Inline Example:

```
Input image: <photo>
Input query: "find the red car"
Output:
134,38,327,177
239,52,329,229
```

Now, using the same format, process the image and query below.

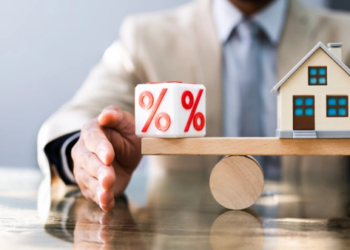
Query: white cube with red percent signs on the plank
135,82,206,138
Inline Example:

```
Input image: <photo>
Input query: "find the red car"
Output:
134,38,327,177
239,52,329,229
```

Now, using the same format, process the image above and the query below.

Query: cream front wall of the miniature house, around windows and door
278,48,350,130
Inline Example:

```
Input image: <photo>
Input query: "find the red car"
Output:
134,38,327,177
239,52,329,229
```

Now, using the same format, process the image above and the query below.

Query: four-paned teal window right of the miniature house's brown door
327,96,349,117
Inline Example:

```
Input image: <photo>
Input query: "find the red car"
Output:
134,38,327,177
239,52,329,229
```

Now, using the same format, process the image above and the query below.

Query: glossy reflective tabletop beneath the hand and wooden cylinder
0,159,350,249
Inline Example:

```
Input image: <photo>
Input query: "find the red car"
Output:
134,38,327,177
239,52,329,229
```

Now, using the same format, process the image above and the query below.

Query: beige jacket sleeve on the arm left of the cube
37,17,146,182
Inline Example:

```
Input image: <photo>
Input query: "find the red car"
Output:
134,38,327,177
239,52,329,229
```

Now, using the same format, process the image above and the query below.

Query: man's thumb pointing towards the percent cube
98,106,135,135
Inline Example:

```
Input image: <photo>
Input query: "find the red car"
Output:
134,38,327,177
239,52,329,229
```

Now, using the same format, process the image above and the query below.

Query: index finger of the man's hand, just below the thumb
81,120,114,165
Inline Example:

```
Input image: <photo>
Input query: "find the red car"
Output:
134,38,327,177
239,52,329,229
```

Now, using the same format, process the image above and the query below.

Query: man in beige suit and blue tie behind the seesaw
38,0,350,211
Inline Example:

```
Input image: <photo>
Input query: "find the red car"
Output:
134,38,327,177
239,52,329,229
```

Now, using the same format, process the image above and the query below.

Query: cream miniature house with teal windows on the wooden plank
273,42,350,138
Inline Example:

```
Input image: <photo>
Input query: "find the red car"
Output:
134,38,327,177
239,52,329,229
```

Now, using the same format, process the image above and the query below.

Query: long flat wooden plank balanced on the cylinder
142,137,350,155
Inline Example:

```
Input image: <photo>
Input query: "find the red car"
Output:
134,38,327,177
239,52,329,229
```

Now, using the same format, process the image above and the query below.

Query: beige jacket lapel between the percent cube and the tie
193,0,222,136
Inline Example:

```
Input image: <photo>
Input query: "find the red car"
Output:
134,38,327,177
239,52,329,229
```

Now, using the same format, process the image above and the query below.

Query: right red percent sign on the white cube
181,89,205,132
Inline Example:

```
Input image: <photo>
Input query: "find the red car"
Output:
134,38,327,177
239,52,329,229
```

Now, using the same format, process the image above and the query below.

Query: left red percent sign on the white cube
139,89,171,133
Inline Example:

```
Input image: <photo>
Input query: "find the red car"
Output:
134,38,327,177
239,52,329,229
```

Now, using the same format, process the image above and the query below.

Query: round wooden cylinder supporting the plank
209,156,264,210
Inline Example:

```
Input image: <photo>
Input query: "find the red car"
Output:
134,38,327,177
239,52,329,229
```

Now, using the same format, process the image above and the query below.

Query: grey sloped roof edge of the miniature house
271,42,350,91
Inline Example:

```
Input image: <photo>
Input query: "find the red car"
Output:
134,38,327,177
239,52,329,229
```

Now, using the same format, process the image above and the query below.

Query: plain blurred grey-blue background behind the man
0,0,350,168
